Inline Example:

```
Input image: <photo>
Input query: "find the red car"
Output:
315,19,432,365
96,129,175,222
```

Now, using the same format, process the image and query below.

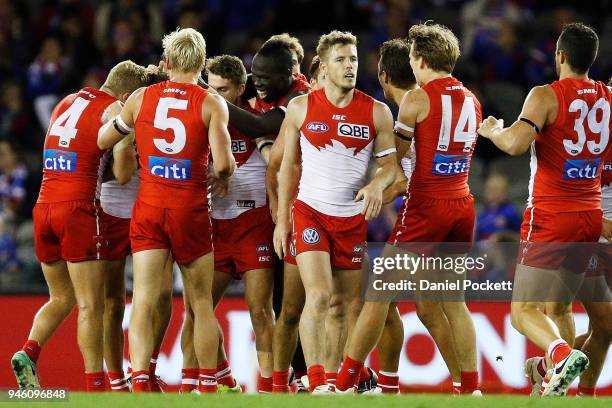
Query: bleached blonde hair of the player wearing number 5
162,28,206,73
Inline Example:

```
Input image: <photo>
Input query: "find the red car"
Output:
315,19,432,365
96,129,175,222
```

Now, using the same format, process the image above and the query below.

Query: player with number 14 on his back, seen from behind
337,24,481,394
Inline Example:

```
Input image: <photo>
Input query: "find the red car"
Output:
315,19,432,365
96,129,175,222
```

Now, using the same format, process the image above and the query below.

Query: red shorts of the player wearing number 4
32,200,104,263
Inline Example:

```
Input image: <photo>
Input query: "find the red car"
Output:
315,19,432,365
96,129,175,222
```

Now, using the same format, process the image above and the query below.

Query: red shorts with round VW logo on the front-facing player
292,200,368,269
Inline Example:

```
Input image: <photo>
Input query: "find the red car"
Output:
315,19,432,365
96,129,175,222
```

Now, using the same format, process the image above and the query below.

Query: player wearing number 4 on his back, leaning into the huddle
11,61,146,391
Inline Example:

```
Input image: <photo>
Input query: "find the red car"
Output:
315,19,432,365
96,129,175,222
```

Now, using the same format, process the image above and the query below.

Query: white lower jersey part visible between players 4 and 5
100,169,140,218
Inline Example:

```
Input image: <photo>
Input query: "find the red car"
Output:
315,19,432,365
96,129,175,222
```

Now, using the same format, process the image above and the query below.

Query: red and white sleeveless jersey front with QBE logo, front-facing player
297,89,376,217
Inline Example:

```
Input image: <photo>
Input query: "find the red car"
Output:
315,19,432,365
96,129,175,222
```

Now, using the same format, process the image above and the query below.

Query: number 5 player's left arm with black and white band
98,88,145,149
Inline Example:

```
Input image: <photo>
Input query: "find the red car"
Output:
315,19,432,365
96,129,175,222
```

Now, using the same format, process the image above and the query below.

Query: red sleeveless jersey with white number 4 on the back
38,88,116,203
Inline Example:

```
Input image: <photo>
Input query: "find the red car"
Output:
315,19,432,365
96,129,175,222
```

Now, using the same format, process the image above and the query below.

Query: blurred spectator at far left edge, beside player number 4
0,141,28,221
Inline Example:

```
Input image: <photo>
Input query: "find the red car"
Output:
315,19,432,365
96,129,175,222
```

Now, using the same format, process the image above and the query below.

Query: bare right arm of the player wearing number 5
202,95,236,179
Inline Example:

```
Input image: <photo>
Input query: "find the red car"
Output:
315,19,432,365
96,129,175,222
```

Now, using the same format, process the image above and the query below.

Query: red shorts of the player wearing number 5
130,200,213,264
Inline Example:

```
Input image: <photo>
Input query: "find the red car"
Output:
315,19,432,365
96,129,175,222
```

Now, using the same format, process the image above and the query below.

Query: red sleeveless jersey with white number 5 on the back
134,81,210,209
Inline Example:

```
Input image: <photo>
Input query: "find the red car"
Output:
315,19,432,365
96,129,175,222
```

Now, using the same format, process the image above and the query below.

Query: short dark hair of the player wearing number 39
557,23,599,74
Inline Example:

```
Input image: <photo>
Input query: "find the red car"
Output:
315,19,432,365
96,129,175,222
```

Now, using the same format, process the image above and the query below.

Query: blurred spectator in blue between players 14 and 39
476,174,521,241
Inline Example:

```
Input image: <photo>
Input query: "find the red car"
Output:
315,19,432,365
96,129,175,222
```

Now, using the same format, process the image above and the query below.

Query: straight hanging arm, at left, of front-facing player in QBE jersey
274,95,308,259
